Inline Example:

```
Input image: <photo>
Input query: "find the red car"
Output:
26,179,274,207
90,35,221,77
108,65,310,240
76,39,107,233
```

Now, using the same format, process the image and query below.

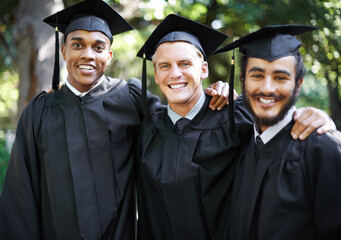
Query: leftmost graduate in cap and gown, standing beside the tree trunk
0,0,161,240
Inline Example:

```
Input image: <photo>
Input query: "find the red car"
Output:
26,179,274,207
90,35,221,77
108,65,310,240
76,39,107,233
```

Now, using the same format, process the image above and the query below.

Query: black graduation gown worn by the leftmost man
0,78,156,240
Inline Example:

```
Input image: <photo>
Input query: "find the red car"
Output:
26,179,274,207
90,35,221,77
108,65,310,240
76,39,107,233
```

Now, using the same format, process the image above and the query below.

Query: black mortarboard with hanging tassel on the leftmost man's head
43,0,133,91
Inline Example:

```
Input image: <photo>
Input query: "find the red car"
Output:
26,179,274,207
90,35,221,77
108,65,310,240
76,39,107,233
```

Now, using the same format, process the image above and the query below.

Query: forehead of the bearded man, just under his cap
246,55,296,72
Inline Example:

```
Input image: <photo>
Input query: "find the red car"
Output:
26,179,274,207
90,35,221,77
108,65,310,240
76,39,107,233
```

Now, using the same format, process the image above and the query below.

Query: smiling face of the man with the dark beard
243,56,303,132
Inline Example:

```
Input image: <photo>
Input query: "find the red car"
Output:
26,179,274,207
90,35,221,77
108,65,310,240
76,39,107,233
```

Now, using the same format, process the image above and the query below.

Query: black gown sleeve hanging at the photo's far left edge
0,93,44,240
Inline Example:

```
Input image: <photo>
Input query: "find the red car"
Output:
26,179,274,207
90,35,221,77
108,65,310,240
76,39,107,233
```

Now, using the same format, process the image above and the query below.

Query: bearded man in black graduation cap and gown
218,25,341,240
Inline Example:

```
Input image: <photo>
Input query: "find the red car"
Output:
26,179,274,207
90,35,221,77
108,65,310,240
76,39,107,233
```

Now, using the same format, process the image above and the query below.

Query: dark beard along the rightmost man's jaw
243,83,299,129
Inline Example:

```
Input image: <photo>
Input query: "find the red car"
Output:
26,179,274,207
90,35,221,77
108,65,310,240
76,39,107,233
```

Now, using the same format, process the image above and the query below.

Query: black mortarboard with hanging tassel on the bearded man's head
215,25,317,130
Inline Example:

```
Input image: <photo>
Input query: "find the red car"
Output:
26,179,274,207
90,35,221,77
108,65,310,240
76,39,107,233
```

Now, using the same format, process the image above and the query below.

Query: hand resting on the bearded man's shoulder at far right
291,107,336,140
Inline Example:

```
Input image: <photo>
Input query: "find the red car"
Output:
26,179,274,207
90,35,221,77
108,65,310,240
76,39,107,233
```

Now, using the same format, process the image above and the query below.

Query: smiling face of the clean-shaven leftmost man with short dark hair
61,30,112,92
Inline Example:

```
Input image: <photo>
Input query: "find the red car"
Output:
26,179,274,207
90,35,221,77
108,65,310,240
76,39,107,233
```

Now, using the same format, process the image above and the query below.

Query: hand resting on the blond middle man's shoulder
205,81,238,111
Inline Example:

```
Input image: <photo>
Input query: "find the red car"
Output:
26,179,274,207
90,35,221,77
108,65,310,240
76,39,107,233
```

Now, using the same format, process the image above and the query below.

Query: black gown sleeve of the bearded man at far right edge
301,131,341,239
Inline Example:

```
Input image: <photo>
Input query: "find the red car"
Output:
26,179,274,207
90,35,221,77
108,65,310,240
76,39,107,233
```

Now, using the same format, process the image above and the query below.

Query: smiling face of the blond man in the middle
153,42,208,116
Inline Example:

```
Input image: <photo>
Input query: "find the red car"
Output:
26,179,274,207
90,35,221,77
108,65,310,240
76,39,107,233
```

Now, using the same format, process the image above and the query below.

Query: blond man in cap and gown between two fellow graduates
137,14,332,240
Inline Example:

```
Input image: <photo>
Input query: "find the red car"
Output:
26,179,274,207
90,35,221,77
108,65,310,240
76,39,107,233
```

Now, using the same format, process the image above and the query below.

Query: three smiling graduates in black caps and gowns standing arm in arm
0,0,341,240
